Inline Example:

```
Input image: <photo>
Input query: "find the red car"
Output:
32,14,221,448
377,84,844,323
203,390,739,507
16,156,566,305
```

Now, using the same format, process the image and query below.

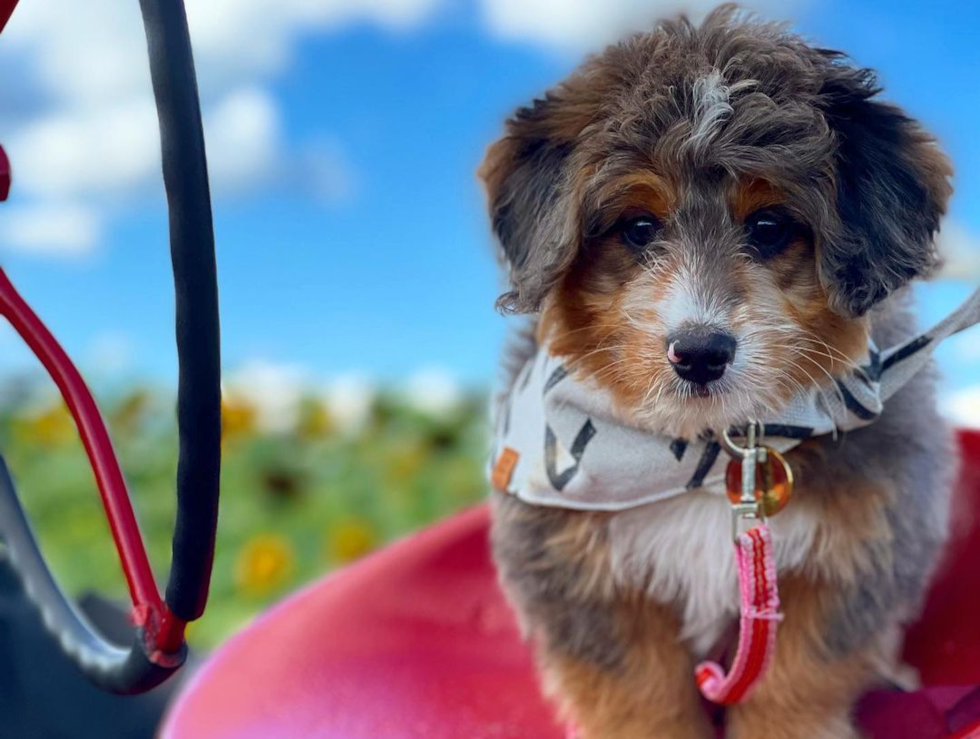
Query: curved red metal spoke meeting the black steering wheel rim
0,269,186,653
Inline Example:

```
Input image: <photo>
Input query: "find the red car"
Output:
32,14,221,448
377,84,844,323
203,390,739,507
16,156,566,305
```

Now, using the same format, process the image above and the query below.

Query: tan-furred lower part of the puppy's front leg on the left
542,597,713,739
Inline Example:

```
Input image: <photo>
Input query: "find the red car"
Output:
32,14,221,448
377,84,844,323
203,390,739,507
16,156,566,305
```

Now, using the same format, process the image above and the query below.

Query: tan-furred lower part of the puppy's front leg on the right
726,577,896,739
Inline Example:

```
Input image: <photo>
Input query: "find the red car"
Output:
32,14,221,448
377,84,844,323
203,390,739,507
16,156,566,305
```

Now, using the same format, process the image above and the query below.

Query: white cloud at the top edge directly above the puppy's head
481,0,808,50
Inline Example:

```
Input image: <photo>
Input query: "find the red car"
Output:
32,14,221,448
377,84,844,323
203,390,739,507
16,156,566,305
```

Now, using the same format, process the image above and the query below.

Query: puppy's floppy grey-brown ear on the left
478,95,579,313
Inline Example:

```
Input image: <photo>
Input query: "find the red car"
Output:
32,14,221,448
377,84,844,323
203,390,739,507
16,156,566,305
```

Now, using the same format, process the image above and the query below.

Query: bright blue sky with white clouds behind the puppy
0,0,980,416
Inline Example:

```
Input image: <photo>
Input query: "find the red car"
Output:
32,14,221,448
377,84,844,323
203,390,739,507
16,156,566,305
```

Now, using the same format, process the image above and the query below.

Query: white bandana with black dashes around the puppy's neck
491,290,980,511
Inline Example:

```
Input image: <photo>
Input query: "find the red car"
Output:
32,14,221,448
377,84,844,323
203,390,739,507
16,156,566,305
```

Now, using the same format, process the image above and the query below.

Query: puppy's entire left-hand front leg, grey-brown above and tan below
491,495,711,739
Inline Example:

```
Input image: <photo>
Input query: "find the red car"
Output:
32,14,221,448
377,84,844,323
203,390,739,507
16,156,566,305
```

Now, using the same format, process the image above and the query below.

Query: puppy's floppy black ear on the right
821,65,952,316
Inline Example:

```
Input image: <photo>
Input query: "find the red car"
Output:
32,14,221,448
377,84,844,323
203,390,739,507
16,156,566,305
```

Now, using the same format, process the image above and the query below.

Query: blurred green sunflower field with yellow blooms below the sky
0,388,487,648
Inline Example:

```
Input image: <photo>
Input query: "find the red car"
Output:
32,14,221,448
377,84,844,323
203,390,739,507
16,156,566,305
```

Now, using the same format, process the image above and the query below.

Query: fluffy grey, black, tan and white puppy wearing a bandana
480,6,955,739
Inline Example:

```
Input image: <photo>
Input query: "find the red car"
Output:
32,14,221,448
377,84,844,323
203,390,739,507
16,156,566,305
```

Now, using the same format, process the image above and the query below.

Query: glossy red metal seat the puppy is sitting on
162,432,980,739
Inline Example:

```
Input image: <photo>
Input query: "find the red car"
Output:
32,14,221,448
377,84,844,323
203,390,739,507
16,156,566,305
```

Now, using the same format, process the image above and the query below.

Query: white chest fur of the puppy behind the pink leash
607,492,820,656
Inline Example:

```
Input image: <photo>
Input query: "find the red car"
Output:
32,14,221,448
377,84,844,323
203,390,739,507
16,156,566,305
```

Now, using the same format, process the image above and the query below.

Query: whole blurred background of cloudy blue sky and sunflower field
0,0,980,650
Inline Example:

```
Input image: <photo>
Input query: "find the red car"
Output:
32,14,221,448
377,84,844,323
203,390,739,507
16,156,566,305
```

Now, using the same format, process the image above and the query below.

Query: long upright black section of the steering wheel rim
140,0,221,621
